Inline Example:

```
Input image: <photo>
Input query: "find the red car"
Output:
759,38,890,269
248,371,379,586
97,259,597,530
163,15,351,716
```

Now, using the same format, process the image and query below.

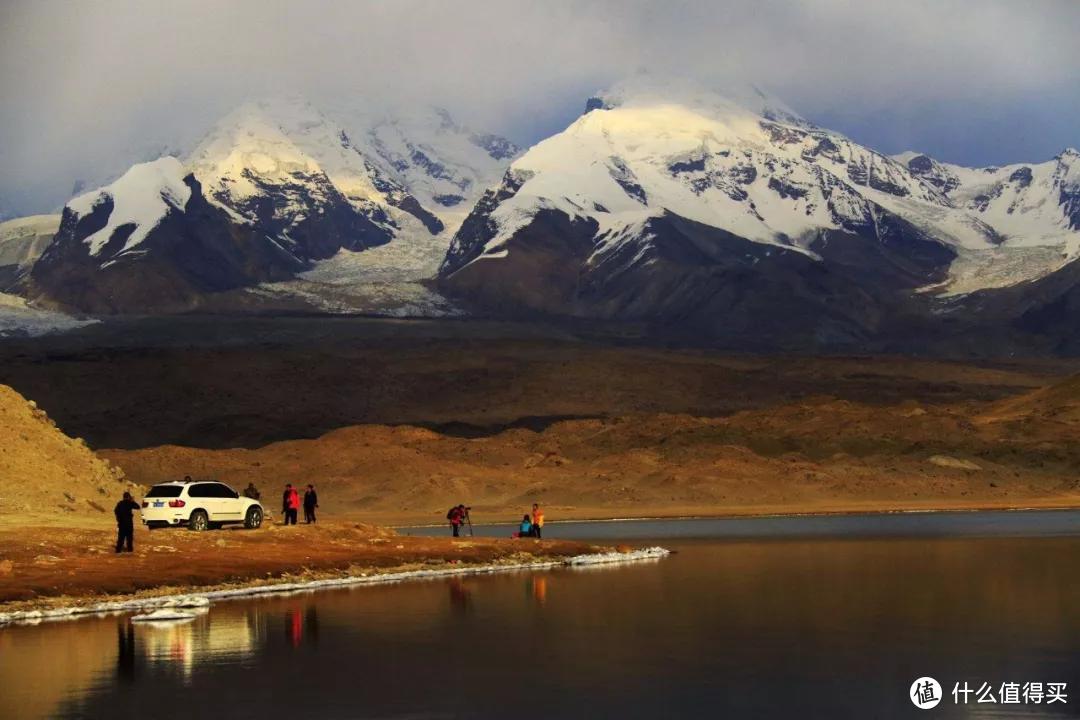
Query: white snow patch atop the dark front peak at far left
67,157,191,256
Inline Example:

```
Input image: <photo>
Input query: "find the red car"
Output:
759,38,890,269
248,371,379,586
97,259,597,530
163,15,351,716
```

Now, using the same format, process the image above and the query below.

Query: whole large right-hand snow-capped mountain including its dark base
441,78,1080,344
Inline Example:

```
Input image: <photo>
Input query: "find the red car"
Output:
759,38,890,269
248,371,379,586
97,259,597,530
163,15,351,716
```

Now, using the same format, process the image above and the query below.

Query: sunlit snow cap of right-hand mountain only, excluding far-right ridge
468,78,959,262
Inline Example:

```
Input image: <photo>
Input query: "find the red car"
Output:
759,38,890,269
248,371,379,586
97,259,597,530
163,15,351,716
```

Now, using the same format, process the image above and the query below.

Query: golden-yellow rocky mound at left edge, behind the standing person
0,385,126,522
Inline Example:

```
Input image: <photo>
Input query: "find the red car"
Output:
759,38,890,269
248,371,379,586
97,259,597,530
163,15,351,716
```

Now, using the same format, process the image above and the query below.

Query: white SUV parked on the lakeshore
141,480,264,530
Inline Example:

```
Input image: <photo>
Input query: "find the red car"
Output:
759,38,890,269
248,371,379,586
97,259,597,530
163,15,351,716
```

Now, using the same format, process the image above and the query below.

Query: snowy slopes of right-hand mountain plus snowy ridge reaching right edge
444,76,1080,304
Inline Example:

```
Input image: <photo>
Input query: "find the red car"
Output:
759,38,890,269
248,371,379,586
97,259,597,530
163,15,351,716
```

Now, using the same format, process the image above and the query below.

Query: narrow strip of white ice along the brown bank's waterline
0,546,671,629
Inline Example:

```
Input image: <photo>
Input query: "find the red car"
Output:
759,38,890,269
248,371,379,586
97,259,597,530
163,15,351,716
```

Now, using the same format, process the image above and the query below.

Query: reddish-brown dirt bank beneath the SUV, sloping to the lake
0,521,598,611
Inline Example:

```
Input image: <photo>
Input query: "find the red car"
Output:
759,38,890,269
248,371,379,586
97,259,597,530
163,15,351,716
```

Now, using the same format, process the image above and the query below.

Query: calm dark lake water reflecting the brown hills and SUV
0,513,1080,719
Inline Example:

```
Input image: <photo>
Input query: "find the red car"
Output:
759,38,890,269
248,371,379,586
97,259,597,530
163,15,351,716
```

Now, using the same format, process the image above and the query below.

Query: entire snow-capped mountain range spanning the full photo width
10,77,1080,352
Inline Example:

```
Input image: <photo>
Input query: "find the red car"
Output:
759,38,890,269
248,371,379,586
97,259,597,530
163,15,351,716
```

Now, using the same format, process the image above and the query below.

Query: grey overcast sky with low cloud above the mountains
0,0,1080,214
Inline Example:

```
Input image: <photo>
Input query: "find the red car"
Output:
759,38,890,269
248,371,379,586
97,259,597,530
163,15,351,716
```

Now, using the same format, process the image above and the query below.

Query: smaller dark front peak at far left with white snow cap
30,158,305,313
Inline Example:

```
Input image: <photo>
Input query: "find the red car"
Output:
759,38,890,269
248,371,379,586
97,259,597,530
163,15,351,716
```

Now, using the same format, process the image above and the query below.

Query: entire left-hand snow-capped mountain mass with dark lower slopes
33,98,514,312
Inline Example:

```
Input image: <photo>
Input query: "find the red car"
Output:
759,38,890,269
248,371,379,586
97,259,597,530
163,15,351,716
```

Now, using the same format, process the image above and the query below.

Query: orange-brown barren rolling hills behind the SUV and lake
103,379,1080,522
